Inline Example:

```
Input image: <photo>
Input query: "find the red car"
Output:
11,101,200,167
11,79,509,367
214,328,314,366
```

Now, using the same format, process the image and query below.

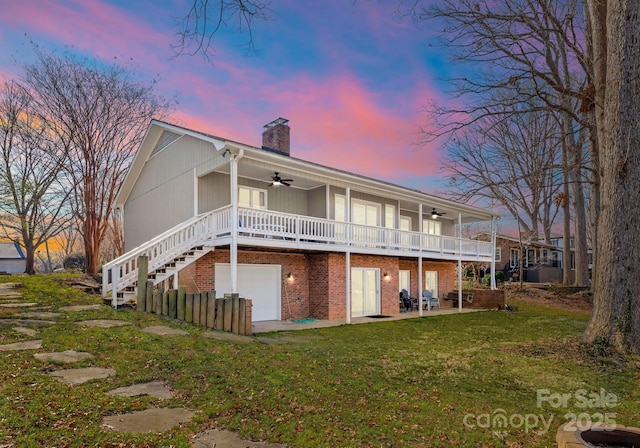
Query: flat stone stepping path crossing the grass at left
0,283,286,448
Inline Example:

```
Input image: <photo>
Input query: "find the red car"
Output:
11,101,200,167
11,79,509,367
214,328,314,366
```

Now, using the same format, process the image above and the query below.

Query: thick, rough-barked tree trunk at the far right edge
586,0,640,353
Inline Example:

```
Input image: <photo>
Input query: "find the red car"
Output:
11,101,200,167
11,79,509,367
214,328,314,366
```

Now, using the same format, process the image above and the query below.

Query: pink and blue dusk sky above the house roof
0,0,455,193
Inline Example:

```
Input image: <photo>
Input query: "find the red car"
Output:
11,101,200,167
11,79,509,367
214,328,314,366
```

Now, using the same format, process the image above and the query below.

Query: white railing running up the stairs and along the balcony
102,206,493,306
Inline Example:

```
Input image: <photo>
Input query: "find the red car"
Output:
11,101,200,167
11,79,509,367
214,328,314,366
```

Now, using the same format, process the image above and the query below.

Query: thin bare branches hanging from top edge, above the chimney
172,0,273,60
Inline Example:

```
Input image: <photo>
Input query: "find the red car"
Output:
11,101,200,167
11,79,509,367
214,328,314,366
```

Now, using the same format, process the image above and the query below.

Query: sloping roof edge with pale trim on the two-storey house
116,120,500,222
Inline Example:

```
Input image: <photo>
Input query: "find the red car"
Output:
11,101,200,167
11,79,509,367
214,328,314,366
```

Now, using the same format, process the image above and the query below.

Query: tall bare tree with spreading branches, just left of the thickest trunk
412,0,589,284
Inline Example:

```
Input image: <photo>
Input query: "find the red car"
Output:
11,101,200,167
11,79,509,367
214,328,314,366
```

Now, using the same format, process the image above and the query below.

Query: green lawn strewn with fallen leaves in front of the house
0,277,640,447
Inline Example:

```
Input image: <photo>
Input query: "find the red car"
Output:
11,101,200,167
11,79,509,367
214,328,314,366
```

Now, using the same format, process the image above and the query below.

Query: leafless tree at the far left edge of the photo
0,82,72,274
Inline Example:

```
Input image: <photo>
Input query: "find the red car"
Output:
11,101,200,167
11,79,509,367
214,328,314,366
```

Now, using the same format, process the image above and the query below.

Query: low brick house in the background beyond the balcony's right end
485,235,562,283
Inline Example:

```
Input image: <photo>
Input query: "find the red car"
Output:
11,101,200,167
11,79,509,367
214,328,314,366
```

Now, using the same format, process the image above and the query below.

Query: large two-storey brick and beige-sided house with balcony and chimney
103,118,497,322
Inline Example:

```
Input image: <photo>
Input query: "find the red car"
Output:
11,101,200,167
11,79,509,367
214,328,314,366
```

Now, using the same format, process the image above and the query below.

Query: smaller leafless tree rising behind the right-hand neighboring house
442,98,560,242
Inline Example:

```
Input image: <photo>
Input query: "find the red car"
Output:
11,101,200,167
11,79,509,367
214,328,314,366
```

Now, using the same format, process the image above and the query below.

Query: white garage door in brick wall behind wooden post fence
215,263,281,322
